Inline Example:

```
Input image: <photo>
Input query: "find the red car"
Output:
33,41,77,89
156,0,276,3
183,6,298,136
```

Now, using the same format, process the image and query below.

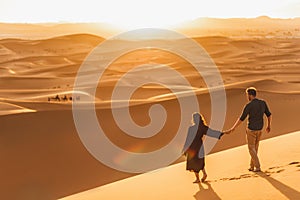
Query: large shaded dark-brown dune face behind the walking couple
0,83,299,199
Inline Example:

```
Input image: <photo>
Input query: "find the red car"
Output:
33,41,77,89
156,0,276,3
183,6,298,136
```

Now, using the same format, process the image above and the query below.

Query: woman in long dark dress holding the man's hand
184,113,227,183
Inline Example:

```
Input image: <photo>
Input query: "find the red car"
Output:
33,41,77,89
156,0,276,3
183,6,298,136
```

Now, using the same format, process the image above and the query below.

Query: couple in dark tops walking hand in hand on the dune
184,87,271,183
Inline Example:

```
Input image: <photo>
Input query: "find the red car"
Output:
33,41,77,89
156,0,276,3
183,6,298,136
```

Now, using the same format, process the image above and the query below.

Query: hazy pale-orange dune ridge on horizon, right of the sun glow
173,16,300,38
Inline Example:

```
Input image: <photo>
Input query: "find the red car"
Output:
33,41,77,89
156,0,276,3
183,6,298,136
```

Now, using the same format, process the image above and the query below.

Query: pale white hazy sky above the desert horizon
0,0,300,28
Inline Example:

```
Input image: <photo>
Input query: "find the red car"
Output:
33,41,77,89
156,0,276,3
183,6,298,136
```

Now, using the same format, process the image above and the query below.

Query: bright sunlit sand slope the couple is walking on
63,132,300,200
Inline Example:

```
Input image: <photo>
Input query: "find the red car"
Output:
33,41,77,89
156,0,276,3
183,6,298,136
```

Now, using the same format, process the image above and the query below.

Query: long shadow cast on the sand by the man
256,172,300,200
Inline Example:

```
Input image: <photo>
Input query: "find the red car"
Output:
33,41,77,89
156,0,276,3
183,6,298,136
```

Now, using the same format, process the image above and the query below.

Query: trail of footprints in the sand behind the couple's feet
207,161,300,182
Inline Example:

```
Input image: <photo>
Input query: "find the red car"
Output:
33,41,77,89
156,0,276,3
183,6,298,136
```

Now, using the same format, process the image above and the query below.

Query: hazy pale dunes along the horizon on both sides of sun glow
0,16,300,39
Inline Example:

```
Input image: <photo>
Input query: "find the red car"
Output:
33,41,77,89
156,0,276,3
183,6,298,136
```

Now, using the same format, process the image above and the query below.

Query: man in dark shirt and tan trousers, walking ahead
229,87,271,172
